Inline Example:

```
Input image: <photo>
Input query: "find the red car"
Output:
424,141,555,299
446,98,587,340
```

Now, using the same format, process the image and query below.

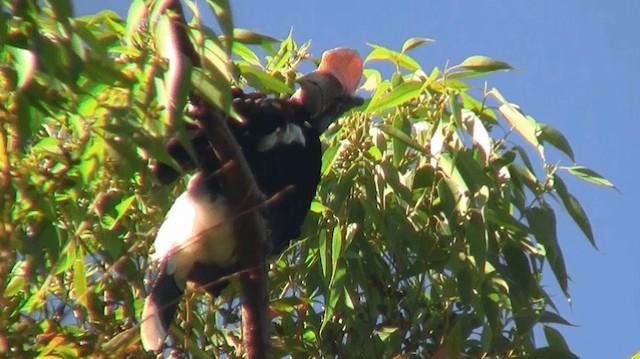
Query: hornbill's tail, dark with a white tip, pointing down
140,266,183,351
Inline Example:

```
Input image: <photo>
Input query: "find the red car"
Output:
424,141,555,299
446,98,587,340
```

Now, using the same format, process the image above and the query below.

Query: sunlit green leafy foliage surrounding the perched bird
0,0,612,358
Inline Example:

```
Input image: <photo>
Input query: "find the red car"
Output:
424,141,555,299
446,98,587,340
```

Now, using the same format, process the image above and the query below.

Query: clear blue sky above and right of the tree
75,0,640,359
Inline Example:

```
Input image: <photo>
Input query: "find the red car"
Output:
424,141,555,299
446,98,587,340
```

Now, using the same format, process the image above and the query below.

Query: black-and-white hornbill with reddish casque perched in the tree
140,48,363,350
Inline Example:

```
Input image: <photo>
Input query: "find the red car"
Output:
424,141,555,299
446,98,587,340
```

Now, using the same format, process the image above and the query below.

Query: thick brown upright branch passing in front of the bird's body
160,0,269,359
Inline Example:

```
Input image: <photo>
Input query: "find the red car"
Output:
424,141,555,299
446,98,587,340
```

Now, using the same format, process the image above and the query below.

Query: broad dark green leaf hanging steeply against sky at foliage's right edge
525,205,569,298
